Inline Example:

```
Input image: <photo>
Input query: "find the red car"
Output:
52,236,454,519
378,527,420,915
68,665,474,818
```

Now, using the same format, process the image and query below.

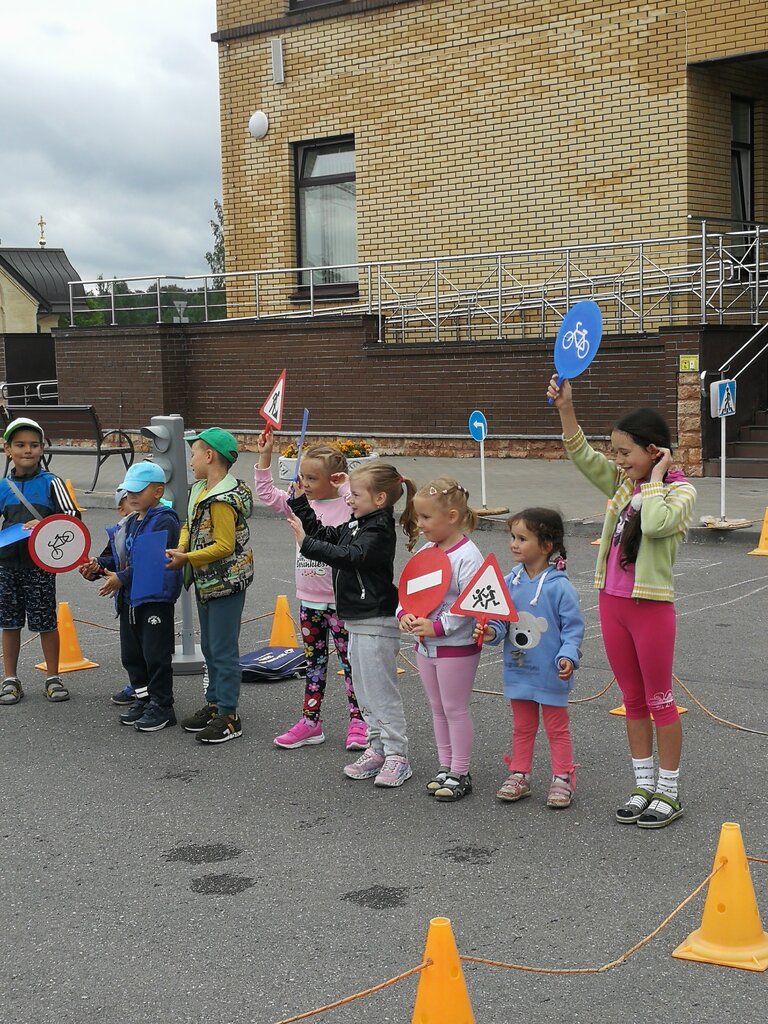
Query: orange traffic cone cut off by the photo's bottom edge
411,918,475,1024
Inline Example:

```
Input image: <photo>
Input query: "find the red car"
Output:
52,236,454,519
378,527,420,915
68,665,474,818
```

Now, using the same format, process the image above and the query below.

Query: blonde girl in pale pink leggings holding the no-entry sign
397,477,482,801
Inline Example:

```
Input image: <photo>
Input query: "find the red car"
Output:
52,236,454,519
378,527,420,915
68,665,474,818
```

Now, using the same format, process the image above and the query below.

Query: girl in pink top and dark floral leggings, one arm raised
254,430,368,751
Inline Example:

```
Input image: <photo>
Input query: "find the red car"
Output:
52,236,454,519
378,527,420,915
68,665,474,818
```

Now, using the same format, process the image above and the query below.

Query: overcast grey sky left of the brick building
0,0,221,280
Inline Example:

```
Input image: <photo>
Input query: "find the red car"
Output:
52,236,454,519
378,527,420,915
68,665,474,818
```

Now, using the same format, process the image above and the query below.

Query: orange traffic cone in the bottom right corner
672,821,768,971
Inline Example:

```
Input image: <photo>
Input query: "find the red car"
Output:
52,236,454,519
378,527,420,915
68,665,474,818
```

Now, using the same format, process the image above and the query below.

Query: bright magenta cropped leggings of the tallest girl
600,591,680,725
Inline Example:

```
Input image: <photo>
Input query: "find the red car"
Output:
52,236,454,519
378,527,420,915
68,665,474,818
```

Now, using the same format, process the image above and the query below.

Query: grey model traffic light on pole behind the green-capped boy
141,415,205,676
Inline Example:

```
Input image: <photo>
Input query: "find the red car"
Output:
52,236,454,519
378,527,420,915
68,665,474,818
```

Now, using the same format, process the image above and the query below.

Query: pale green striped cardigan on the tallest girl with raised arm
563,427,696,601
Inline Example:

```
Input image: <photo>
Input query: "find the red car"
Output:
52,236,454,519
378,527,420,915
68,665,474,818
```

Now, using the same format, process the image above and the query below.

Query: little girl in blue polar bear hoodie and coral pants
475,508,584,808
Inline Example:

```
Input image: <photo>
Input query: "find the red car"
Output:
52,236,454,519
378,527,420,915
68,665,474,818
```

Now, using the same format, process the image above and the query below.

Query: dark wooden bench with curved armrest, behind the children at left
3,406,135,494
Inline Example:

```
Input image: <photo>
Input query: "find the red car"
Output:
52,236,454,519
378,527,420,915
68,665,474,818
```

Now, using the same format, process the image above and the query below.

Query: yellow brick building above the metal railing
214,0,768,296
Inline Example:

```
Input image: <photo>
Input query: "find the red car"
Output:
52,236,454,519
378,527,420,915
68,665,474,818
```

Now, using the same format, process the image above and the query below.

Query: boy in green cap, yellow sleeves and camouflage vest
168,427,253,743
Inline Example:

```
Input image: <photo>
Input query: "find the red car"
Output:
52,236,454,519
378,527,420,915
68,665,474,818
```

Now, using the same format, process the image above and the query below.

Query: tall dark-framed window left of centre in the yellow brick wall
296,137,357,286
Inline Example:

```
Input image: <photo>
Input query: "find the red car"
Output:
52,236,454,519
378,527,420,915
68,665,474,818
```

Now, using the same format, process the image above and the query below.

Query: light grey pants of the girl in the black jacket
346,620,408,757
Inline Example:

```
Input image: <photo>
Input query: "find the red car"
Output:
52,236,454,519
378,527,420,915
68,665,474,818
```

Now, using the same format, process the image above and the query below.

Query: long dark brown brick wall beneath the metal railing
56,316,738,471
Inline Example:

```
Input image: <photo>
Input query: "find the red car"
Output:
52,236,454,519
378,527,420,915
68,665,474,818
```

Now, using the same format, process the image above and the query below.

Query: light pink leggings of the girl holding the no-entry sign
416,649,480,775
